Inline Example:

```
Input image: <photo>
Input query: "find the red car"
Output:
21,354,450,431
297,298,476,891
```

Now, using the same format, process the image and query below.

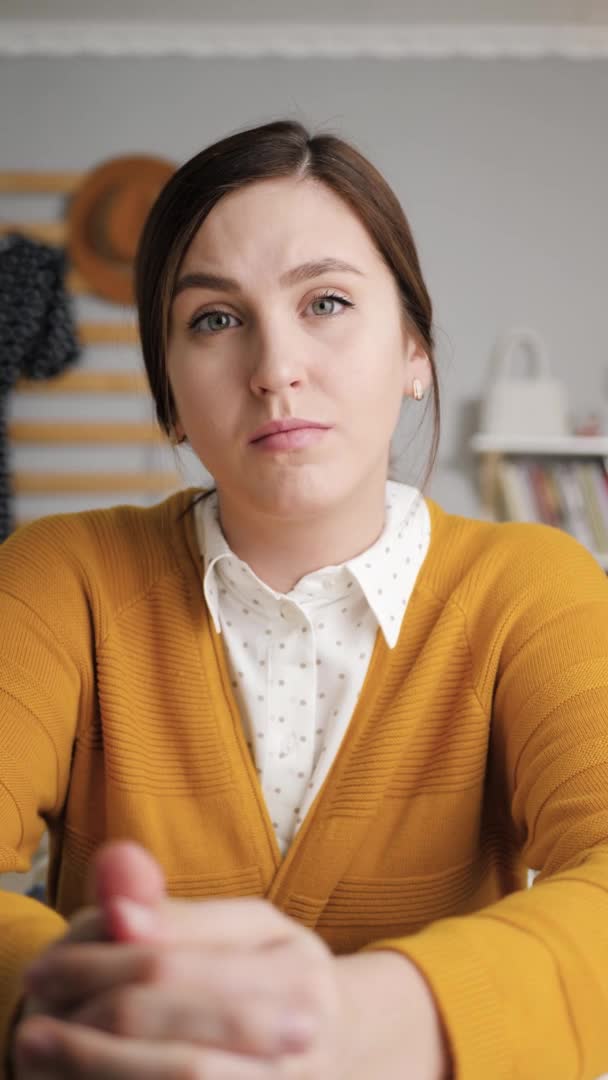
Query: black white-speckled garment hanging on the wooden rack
0,233,80,542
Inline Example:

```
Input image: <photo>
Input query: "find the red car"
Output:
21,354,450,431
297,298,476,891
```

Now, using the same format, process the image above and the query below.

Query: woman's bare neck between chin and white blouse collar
218,485,386,593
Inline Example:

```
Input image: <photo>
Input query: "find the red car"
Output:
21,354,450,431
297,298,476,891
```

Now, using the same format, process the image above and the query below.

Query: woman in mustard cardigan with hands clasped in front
0,122,608,1080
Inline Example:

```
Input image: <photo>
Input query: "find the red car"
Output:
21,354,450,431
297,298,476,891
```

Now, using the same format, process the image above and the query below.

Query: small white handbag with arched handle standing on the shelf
479,329,570,436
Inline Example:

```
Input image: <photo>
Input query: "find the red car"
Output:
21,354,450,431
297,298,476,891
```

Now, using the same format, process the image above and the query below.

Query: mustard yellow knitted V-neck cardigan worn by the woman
0,490,608,1080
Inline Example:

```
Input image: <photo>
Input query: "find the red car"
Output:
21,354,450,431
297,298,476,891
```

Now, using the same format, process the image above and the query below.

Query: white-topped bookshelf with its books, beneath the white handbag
471,434,608,570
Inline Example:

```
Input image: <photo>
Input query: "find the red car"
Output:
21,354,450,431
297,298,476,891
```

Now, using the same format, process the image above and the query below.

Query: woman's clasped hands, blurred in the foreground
14,841,445,1080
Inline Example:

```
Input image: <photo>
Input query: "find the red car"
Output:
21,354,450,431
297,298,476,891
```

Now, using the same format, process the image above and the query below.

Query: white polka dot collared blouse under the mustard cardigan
194,481,430,855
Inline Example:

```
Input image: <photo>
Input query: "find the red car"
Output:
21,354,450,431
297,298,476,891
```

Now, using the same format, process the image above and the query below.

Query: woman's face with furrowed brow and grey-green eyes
167,177,429,517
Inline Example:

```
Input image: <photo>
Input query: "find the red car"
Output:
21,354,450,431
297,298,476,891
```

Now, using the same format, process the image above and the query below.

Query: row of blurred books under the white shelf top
497,456,608,554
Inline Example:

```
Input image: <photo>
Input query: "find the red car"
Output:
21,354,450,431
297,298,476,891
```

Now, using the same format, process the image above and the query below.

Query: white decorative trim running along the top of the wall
0,19,608,59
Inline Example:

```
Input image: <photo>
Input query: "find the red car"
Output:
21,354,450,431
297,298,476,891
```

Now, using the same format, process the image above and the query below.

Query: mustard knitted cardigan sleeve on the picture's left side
0,519,91,1057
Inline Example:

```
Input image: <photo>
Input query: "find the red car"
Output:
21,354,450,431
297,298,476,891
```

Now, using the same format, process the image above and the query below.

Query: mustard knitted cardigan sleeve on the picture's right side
367,527,608,1080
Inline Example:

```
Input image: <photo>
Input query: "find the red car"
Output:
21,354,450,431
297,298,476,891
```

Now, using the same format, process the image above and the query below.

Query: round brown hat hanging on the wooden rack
67,154,176,303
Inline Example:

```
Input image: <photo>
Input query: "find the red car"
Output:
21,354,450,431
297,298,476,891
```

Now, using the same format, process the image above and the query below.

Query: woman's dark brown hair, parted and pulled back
135,120,440,482
